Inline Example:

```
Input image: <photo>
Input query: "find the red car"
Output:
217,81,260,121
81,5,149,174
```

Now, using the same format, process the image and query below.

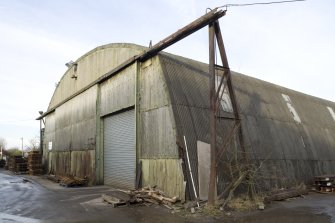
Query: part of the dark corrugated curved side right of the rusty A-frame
234,74,335,188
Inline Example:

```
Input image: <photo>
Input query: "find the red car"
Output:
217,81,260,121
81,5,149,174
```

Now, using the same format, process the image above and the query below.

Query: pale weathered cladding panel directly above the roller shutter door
100,64,136,116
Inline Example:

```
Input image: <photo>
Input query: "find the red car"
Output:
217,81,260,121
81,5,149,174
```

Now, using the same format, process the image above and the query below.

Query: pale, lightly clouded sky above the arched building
0,0,335,147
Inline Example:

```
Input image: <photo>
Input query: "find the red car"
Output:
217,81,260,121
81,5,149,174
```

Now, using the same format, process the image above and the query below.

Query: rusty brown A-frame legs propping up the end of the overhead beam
208,17,247,206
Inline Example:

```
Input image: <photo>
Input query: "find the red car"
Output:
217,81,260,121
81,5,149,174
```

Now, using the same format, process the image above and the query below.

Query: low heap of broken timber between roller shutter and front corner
102,186,179,210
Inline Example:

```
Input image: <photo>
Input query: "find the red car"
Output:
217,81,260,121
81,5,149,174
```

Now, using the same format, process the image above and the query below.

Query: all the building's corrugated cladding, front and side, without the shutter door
40,44,335,200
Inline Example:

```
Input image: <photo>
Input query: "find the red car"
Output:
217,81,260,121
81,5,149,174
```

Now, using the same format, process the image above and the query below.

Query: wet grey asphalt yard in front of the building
0,169,335,223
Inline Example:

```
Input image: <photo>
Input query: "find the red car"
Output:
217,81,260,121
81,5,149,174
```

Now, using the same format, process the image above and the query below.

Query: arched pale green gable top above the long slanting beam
48,43,147,111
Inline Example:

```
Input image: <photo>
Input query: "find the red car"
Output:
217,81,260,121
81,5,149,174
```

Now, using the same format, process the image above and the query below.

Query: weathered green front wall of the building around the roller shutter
44,44,185,198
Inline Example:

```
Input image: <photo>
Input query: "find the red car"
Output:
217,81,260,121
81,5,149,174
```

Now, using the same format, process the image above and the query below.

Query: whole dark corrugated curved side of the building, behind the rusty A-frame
160,53,335,196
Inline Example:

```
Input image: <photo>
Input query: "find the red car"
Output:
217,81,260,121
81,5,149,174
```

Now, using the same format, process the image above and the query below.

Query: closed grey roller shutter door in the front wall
104,109,136,189
